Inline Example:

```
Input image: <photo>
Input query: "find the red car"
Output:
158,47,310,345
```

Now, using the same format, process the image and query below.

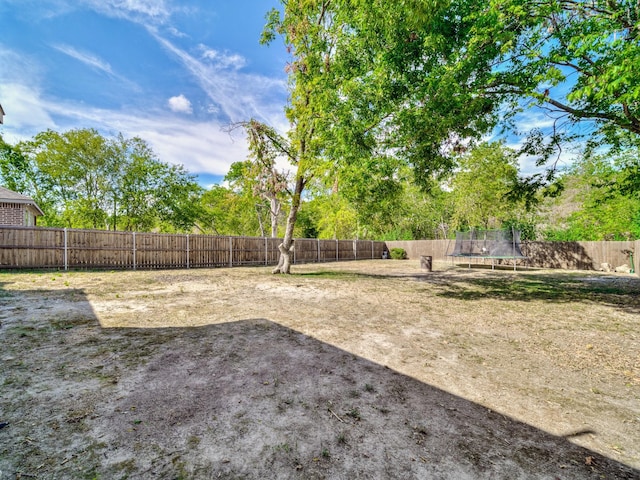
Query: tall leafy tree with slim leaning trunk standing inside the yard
264,0,495,273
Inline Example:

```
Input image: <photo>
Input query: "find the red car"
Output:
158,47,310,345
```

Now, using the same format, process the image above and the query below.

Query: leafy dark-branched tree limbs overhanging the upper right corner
460,0,640,182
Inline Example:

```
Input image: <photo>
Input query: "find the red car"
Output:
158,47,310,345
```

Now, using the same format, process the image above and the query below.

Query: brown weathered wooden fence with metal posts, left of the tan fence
0,226,386,270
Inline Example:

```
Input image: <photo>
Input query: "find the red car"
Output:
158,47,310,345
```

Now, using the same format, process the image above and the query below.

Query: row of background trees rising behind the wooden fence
0,129,640,241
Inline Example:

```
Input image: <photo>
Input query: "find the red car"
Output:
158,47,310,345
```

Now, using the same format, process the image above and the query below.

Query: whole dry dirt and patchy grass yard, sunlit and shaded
0,260,640,480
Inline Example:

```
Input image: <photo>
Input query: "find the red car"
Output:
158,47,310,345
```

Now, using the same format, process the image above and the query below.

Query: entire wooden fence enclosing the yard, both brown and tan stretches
0,226,640,274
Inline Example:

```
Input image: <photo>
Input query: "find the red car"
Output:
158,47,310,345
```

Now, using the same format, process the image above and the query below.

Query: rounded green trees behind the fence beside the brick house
0,129,201,232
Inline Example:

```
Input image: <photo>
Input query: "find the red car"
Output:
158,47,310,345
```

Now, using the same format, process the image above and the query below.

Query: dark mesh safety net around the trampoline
449,229,527,259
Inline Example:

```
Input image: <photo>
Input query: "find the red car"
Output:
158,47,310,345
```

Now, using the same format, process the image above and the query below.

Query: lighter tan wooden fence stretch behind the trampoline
386,240,640,274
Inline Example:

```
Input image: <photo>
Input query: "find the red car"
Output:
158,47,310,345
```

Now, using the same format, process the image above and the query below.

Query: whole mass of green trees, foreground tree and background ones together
3,0,640,273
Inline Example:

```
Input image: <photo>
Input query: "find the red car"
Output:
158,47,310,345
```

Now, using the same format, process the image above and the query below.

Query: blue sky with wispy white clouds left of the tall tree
0,0,287,185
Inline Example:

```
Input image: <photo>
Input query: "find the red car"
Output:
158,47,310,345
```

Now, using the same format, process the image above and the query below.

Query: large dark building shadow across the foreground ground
0,289,640,479
